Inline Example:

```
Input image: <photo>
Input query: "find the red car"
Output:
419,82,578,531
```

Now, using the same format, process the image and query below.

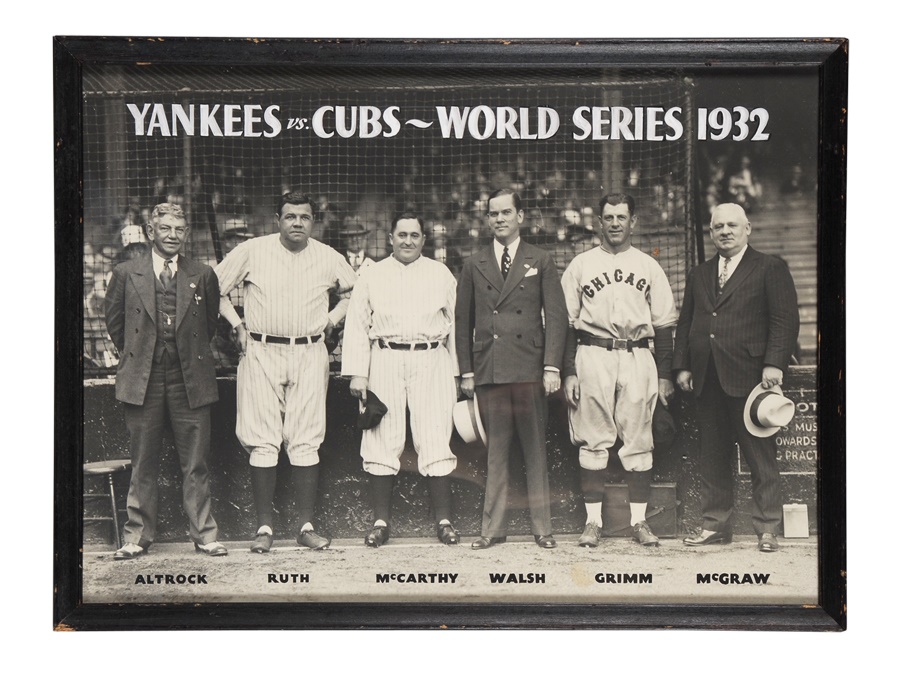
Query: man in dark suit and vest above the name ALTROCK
106,203,228,560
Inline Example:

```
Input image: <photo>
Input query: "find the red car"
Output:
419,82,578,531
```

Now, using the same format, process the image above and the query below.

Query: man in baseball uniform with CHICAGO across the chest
562,194,677,547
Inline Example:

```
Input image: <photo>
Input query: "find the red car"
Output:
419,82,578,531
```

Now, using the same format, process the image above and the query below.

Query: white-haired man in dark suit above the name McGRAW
672,203,800,552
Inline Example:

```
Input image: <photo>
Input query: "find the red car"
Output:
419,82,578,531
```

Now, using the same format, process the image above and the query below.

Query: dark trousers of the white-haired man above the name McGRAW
697,359,782,535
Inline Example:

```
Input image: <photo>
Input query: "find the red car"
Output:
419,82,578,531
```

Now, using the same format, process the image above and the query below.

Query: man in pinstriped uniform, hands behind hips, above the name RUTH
216,192,356,553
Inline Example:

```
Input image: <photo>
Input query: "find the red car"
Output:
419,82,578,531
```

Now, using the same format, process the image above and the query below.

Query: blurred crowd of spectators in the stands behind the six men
84,151,808,373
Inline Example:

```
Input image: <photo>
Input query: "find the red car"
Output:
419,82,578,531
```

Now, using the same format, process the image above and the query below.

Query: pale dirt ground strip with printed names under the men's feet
83,535,818,604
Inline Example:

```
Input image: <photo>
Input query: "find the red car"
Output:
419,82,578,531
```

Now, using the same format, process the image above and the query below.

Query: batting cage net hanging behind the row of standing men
84,67,694,376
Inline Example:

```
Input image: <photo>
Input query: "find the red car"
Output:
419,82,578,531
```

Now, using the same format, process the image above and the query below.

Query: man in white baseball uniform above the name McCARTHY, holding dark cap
341,212,459,547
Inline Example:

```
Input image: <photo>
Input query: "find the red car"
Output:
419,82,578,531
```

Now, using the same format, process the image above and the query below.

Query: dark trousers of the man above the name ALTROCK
125,355,218,546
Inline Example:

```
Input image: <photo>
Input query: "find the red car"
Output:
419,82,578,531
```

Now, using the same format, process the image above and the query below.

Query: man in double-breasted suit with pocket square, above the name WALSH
456,189,568,549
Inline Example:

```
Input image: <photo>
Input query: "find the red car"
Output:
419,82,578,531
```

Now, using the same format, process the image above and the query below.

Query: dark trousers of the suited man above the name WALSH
475,382,553,538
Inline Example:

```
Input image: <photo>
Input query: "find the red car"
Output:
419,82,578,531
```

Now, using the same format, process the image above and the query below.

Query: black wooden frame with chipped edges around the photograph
53,37,848,631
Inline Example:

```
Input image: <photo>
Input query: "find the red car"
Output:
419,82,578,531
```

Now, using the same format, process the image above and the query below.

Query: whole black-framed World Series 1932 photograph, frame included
53,37,848,631
